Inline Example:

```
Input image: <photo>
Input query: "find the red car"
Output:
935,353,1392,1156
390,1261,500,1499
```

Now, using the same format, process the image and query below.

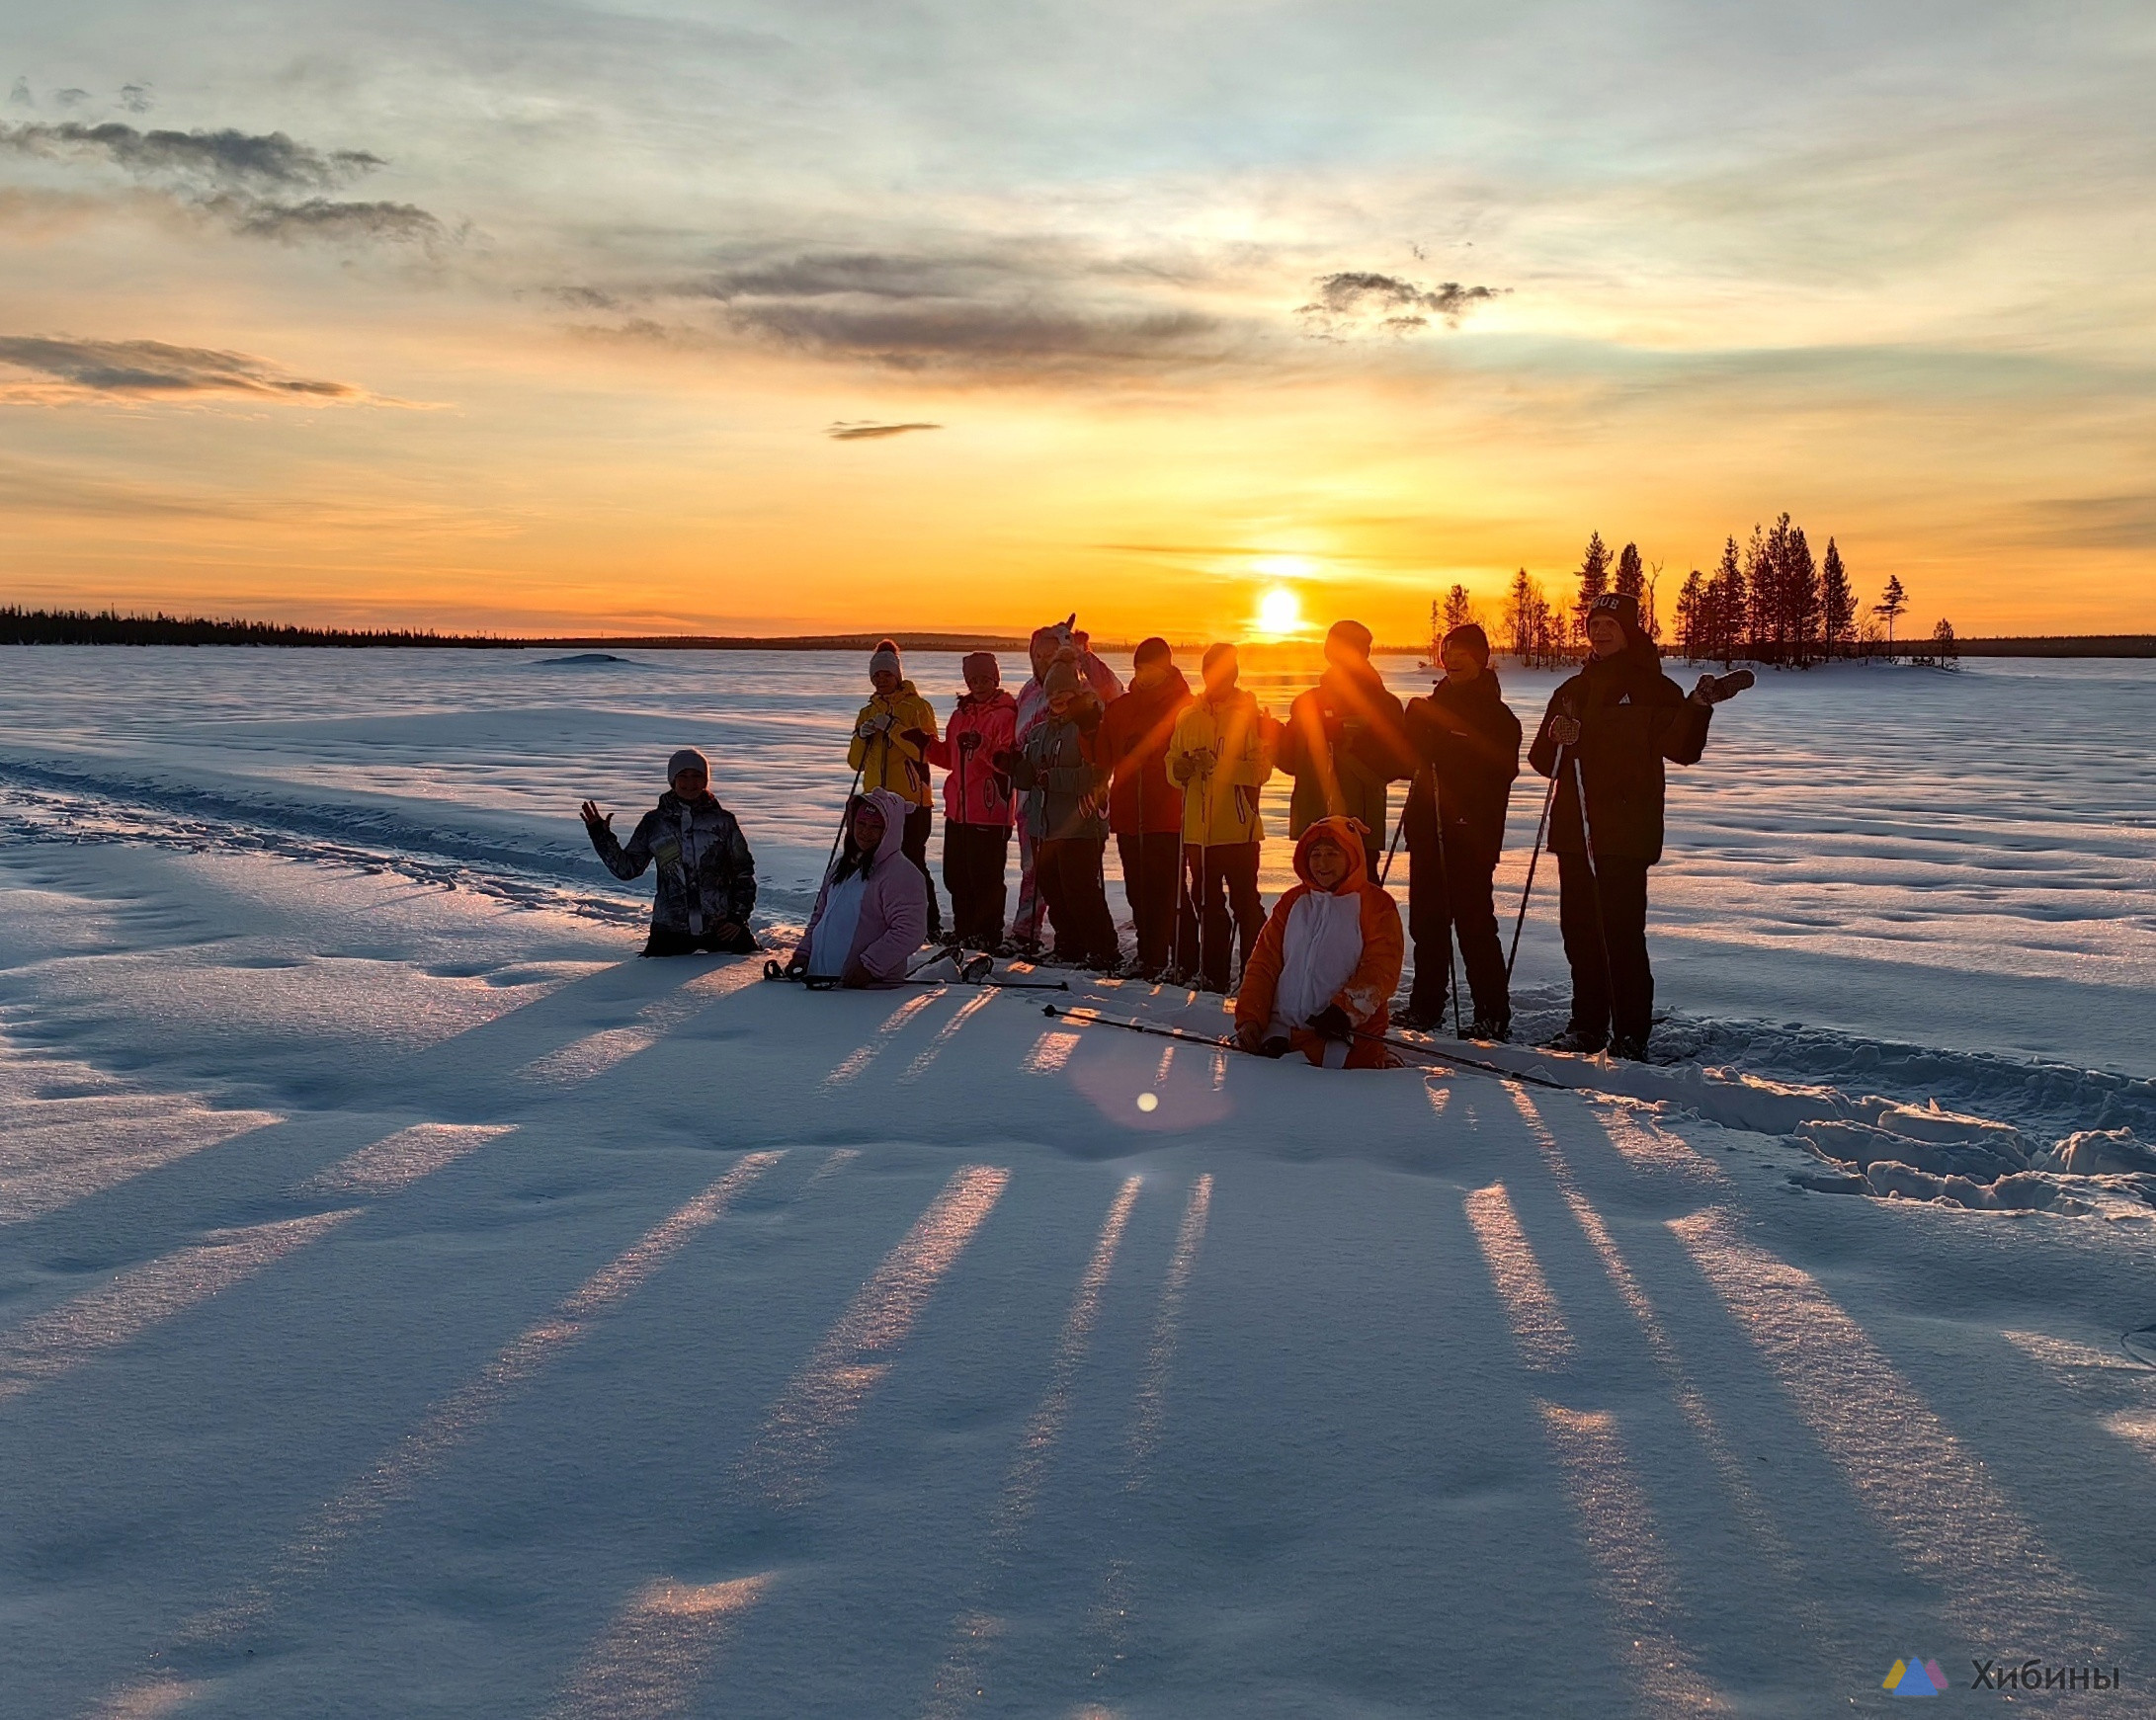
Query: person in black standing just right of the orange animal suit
1393,620,1520,1039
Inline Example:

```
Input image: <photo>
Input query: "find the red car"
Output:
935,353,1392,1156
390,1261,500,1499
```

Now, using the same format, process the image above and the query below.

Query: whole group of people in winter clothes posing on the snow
582,593,1714,1067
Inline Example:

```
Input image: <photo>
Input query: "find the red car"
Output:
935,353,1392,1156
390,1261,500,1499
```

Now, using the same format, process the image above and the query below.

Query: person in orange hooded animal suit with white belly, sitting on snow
1235,817,1401,1069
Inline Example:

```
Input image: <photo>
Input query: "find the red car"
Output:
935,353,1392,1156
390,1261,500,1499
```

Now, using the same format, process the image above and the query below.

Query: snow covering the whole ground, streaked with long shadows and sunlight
0,651,2156,1720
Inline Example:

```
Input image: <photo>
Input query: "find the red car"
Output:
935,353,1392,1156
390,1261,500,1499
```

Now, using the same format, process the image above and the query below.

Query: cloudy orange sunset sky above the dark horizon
0,0,2156,640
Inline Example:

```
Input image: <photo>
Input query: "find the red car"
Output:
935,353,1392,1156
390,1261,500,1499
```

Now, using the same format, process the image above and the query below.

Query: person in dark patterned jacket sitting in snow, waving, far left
582,746,757,954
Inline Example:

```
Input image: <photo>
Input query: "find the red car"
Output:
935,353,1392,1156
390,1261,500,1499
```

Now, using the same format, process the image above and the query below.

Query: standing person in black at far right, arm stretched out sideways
1527,591,1714,1058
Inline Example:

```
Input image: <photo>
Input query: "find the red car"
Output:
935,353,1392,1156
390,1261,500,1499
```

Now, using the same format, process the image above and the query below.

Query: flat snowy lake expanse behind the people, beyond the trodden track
0,649,2156,1073
